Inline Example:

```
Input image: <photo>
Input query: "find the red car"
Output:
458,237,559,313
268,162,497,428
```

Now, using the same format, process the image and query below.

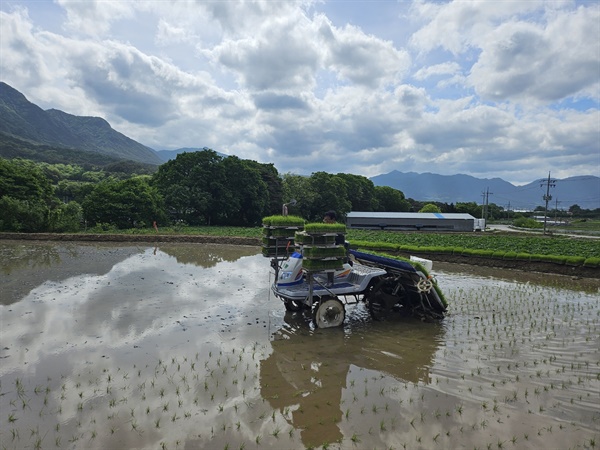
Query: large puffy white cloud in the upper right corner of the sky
469,7,600,103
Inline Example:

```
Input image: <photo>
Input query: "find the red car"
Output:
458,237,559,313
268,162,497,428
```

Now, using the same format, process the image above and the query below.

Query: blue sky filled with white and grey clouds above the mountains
0,0,600,185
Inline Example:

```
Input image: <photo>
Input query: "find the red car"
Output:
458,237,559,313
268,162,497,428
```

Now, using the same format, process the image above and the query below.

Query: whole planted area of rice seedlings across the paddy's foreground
0,276,600,449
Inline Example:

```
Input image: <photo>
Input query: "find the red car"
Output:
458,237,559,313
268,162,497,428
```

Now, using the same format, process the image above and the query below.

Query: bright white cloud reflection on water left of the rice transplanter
0,245,269,374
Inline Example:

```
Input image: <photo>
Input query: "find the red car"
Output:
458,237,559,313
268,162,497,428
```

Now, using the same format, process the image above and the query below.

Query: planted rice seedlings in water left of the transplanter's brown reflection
0,344,308,449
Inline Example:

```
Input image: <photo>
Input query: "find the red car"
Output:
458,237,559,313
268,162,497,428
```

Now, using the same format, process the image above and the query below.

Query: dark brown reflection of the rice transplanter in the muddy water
260,313,444,447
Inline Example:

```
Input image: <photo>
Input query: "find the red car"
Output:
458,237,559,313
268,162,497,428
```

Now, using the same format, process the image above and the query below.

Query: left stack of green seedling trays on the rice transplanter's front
262,216,304,258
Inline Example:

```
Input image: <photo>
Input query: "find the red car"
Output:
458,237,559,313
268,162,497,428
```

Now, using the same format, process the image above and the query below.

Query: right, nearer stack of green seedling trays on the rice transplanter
295,223,346,272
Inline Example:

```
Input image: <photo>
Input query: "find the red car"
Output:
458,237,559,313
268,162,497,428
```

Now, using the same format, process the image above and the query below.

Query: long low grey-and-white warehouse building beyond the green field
346,211,485,231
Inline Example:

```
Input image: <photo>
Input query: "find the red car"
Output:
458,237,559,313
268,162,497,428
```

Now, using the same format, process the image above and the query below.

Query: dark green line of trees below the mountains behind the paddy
0,153,596,232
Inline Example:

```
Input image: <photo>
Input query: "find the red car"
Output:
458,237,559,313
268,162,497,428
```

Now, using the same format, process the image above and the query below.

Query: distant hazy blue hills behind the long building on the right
371,170,600,210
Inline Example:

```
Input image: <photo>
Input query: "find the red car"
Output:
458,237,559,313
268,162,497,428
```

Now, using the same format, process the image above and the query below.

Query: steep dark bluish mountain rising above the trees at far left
0,82,163,165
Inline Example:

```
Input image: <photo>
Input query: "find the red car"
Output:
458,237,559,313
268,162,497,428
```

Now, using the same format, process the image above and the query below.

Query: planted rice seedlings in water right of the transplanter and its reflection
328,280,600,448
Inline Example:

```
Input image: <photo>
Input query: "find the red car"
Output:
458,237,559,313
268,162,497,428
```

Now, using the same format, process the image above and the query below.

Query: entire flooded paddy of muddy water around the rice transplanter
0,242,600,449
